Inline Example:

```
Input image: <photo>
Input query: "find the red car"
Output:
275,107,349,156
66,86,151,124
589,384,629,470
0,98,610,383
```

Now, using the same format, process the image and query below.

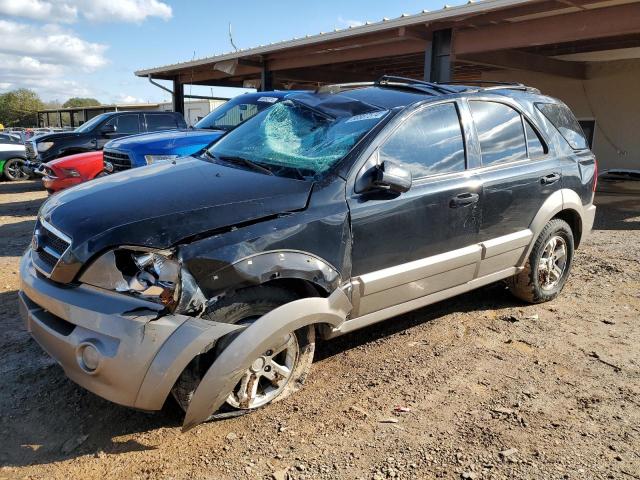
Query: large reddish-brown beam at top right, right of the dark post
453,3,640,55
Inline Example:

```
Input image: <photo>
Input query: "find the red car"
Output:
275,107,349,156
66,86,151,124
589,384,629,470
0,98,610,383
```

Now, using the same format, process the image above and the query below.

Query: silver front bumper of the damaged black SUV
19,250,242,410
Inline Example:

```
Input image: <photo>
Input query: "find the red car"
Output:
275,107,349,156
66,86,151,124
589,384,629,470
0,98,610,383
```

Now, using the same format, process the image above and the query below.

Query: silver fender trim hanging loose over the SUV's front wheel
182,289,352,432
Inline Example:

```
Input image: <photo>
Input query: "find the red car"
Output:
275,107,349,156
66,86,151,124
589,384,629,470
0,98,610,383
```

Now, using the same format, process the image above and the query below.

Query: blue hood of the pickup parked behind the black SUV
105,129,225,154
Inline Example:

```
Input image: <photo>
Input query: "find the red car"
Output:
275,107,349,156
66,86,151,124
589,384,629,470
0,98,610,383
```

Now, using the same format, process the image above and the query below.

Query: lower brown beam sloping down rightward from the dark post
456,50,587,79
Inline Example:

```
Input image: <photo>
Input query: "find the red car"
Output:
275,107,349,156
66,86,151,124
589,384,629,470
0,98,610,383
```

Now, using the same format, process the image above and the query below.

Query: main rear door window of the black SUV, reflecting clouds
469,101,527,166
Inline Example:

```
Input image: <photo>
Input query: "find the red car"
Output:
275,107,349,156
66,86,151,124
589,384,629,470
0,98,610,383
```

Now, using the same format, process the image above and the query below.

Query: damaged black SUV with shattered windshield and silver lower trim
20,77,596,428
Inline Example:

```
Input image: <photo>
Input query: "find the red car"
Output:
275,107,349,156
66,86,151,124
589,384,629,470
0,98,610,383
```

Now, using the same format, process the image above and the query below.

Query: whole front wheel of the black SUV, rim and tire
172,286,315,412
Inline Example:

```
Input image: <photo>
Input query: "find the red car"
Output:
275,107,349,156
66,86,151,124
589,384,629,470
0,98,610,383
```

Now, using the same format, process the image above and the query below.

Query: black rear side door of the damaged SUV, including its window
468,99,561,246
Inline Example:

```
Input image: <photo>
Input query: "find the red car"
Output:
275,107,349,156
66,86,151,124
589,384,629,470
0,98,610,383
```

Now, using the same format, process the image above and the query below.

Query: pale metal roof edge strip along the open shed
135,0,528,78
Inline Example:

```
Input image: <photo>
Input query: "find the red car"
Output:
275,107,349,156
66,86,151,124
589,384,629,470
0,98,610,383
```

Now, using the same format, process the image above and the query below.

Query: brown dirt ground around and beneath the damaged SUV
0,182,640,480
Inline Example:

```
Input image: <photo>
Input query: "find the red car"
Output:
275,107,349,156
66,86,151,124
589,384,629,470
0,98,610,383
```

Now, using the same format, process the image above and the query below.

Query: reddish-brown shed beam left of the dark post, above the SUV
268,40,426,71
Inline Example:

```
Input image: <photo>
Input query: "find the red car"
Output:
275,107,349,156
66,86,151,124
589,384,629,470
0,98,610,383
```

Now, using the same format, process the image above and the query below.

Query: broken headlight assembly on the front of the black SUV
80,248,180,310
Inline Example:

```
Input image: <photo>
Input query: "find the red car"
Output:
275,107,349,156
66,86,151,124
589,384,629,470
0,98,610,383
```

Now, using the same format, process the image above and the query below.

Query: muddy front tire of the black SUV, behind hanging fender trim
171,286,315,418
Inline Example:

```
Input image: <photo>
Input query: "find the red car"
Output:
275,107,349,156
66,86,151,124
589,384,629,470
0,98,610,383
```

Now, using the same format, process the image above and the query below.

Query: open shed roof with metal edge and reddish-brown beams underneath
135,0,640,90
